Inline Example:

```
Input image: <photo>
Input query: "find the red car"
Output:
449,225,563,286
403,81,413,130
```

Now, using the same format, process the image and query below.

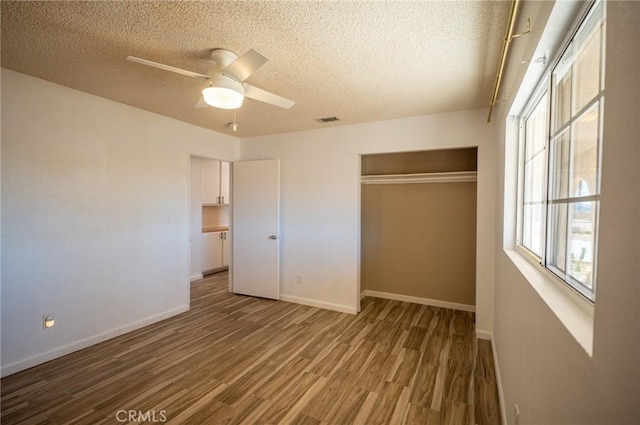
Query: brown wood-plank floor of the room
1,273,500,425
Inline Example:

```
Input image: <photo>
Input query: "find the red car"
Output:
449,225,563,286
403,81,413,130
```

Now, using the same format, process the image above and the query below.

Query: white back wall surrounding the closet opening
240,109,495,335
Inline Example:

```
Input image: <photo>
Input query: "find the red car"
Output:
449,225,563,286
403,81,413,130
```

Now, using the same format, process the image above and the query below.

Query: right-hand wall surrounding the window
494,1,640,425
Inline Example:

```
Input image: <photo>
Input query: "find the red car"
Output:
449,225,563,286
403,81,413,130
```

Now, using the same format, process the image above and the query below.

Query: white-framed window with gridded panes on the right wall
518,2,604,301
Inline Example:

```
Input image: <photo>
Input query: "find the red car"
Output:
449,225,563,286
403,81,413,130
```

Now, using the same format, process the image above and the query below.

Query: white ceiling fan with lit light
127,49,295,109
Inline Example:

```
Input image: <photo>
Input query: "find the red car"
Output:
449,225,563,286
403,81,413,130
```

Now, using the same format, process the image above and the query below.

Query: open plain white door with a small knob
231,159,280,299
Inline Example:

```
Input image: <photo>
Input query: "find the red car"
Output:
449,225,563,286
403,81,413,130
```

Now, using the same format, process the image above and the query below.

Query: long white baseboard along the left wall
0,305,189,378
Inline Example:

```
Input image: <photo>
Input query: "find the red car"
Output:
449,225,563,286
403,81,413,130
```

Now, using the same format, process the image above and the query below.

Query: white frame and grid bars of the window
515,0,606,307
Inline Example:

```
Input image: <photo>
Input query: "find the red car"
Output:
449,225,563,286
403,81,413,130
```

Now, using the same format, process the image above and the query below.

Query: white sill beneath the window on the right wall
504,248,594,357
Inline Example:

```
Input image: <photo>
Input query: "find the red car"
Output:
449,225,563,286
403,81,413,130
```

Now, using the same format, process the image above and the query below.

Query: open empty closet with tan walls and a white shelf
360,147,477,311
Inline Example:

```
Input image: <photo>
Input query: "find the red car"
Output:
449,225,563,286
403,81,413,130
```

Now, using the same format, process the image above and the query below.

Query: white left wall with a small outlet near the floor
2,69,239,374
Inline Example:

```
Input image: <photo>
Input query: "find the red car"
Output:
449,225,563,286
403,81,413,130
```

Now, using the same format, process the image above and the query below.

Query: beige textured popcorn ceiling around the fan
1,1,510,137
